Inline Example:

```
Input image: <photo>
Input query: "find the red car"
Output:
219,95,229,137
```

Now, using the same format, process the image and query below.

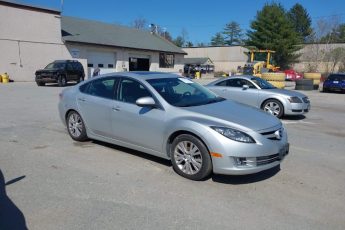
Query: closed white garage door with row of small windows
87,51,116,68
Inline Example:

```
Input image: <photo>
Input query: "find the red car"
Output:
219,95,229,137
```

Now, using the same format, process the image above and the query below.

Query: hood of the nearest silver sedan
184,100,281,131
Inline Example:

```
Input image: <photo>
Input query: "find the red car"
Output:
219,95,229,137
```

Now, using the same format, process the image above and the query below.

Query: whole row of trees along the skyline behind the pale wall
133,2,345,69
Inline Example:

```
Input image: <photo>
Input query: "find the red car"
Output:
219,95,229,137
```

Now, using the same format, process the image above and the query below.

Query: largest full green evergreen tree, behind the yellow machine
247,3,302,69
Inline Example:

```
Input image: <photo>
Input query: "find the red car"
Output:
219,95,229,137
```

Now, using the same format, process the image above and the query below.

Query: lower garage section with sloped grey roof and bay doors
62,17,186,77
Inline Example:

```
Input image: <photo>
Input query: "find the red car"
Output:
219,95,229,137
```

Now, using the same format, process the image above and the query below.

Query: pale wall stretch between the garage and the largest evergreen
183,46,248,72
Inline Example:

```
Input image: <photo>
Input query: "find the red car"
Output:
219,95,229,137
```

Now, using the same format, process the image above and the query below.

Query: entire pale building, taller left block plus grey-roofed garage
0,0,186,81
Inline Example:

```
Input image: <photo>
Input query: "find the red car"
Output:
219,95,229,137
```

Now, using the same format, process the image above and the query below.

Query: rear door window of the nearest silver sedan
87,78,115,99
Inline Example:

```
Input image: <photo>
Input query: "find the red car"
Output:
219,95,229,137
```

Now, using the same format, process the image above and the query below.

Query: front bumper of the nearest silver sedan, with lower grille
208,127,290,175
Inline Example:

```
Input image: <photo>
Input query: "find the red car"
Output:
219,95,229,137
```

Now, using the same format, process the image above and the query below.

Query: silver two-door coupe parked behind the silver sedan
206,76,310,118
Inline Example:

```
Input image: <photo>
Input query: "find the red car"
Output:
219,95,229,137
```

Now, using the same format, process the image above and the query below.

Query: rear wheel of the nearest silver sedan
66,111,87,141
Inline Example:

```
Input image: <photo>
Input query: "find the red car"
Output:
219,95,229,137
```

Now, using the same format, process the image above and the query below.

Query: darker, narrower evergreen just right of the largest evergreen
288,3,313,42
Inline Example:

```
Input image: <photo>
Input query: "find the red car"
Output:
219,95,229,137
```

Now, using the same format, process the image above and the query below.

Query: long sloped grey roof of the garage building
61,16,186,54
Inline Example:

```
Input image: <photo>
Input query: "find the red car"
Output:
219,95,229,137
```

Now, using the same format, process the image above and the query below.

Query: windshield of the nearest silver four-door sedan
147,78,225,107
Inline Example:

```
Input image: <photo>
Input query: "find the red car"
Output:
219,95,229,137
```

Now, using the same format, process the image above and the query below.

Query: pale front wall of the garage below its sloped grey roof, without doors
67,44,184,76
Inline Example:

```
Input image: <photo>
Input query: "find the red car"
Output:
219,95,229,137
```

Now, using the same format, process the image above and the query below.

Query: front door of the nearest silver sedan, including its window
111,77,166,153
